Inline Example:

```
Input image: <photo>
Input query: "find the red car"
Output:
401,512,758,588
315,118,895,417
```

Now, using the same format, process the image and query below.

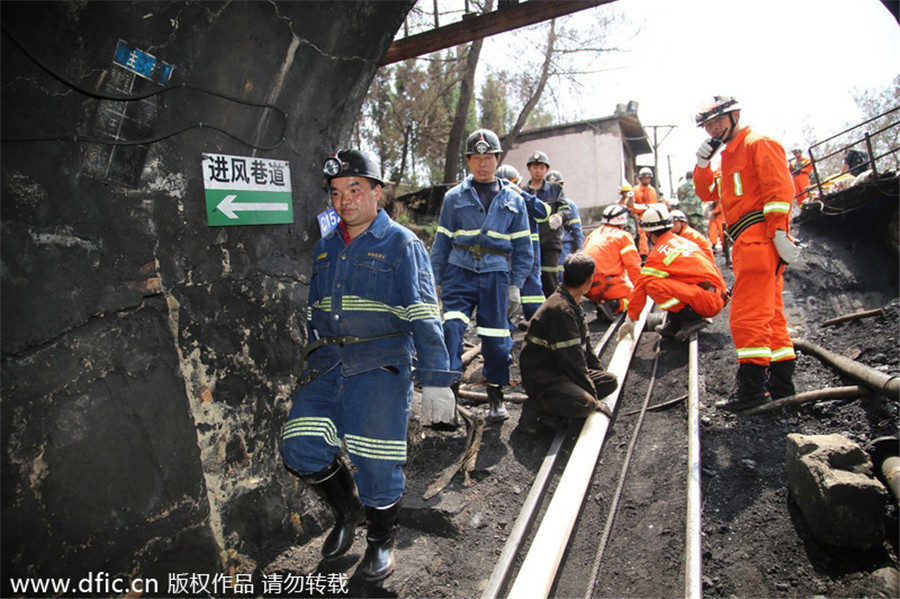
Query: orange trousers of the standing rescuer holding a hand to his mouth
729,238,796,366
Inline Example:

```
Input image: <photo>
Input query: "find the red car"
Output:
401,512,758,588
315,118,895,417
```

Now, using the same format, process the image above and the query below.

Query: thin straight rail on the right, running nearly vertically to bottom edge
684,333,703,599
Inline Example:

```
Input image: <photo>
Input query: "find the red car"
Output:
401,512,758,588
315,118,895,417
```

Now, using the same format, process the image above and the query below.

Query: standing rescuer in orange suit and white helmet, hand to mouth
694,96,800,410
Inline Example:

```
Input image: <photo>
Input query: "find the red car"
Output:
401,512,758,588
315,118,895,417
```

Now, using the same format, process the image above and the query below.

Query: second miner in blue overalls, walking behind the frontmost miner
431,129,533,422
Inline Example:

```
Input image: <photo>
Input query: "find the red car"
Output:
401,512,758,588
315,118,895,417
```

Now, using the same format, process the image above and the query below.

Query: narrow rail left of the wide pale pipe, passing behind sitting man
481,315,623,599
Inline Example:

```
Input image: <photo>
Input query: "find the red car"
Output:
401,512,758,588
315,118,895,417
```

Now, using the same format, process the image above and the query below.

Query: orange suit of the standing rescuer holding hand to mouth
694,127,796,366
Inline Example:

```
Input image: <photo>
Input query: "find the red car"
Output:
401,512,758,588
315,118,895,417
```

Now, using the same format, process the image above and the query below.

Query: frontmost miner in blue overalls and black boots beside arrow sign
281,150,459,581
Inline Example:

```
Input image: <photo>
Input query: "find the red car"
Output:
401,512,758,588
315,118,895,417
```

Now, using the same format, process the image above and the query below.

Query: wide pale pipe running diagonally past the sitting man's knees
508,301,653,597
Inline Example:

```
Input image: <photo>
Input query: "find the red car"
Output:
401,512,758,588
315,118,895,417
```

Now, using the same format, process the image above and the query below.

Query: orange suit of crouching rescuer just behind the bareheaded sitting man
583,225,641,312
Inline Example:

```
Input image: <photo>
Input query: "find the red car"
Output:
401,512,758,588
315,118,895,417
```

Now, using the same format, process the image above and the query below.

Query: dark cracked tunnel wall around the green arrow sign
0,0,414,596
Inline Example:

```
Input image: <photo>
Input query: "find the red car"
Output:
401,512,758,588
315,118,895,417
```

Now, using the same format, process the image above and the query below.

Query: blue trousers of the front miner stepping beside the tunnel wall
281,364,413,507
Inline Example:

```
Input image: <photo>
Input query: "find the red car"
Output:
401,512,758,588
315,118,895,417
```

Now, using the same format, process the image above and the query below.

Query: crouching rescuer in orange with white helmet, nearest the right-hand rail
619,207,729,341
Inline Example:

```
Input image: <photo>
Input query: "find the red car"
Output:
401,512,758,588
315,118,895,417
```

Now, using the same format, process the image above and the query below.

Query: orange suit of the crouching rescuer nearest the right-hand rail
628,230,728,320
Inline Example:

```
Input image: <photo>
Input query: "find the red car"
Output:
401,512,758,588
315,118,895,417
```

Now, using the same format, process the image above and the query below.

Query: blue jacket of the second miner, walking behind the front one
431,175,534,288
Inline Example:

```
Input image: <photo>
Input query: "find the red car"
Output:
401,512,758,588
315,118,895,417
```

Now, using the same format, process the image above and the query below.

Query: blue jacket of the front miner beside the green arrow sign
306,209,459,387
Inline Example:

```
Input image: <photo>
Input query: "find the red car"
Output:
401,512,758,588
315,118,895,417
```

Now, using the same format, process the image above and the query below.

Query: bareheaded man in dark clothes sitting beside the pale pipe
519,252,617,433
